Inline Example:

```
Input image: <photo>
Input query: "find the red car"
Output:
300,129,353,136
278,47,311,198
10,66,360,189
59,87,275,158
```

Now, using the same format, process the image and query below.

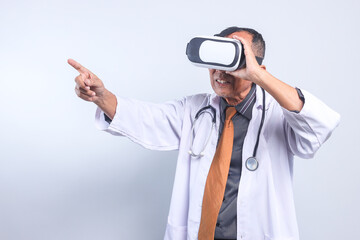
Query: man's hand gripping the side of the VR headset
226,35,266,83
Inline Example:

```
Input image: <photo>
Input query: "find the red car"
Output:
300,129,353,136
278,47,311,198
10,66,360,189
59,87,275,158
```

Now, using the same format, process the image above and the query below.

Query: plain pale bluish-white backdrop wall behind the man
0,0,360,240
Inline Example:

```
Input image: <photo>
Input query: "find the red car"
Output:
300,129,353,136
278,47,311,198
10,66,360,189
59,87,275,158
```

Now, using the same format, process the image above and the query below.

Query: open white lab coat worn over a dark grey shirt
96,86,340,240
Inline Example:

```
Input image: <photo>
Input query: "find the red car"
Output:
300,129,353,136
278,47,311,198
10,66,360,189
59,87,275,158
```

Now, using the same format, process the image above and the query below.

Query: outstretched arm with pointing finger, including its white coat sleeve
68,59,185,150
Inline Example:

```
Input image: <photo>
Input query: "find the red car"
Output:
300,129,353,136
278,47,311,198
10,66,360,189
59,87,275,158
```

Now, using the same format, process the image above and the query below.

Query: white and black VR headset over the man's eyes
186,37,263,72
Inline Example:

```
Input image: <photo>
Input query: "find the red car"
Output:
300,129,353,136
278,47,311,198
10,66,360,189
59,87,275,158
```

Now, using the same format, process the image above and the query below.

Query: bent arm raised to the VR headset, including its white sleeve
227,36,340,158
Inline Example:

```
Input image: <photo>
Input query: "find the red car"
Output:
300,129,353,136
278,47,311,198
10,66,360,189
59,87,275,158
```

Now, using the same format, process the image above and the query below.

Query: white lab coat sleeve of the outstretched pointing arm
95,97,186,150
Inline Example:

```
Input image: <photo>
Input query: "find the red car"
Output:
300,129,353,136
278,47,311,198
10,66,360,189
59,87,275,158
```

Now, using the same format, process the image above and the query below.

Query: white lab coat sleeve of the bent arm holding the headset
282,90,340,158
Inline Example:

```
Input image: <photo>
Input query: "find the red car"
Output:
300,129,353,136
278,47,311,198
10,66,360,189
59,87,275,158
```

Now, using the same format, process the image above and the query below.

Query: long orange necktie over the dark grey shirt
198,107,236,240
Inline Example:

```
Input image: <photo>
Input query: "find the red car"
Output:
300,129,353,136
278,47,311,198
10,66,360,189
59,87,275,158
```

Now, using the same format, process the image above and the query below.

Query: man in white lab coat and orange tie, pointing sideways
68,27,340,240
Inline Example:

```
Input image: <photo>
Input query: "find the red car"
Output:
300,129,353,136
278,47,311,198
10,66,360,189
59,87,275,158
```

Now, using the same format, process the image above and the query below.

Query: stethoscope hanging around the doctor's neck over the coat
189,88,265,171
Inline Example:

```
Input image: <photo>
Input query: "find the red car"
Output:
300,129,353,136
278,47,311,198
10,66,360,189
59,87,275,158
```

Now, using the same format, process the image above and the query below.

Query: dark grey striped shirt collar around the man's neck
220,83,256,120
